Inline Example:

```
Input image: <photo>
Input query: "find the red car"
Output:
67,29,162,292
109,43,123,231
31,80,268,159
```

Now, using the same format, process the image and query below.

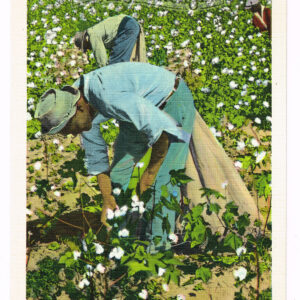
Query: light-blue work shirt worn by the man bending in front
74,62,190,175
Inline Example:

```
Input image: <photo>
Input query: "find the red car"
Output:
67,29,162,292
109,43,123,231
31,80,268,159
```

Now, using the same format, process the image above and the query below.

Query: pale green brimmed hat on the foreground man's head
34,86,80,134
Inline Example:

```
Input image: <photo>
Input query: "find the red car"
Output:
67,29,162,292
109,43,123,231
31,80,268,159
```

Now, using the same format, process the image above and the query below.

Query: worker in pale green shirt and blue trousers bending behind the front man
74,15,147,67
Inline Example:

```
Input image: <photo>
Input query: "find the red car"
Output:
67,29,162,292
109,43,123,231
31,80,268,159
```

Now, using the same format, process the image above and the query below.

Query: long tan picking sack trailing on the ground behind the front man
186,113,262,232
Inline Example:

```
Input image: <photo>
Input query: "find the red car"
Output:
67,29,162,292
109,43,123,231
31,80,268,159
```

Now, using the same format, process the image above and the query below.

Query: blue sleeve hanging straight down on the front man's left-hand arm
81,115,109,175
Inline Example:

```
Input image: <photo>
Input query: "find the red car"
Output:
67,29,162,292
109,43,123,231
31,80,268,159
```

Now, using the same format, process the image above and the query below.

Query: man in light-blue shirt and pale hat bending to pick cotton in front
35,62,195,243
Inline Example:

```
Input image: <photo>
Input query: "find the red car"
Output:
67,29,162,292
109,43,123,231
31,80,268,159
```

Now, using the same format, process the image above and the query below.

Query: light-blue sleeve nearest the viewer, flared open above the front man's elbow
101,92,190,147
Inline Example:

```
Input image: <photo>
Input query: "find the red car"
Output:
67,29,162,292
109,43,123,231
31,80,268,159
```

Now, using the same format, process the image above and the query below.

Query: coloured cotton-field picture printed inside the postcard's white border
9,0,284,300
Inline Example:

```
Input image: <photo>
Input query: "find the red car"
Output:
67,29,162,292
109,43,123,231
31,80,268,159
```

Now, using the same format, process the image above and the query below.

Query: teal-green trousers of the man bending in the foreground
110,80,195,241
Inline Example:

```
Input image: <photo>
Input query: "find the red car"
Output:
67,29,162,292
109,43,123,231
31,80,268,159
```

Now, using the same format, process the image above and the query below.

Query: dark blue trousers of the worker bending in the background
108,16,140,65
